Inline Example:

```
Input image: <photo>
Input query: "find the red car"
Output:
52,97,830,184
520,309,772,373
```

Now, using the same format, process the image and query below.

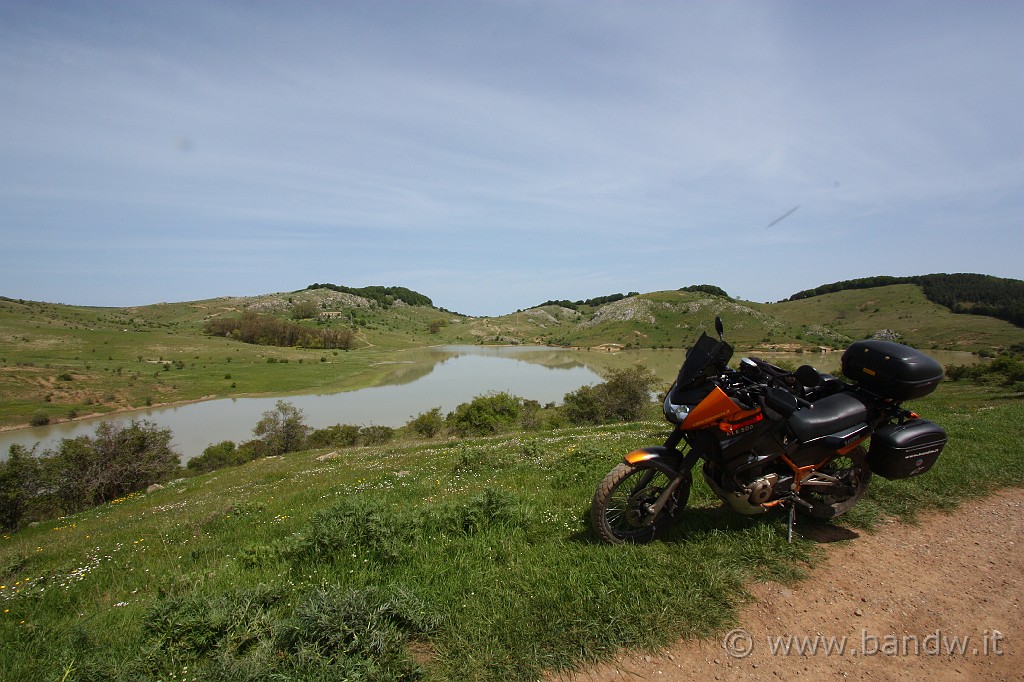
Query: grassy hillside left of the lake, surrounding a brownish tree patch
0,291,468,426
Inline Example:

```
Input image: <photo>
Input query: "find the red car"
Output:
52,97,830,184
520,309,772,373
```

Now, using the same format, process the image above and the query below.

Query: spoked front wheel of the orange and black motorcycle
590,462,690,545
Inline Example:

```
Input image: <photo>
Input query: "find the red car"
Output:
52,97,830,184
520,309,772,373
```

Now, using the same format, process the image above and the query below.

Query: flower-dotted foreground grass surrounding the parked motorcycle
0,383,1024,680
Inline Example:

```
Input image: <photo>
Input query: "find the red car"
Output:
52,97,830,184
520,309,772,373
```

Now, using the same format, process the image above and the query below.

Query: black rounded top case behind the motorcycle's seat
843,340,943,400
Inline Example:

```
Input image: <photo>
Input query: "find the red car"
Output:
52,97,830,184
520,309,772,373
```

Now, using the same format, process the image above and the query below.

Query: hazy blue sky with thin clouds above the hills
0,0,1024,315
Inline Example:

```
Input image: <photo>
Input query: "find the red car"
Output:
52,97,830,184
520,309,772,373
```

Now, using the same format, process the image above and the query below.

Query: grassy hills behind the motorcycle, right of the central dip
469,285,1024,351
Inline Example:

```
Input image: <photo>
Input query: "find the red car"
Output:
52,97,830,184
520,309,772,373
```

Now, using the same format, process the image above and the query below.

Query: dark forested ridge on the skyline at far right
788,272,1024,327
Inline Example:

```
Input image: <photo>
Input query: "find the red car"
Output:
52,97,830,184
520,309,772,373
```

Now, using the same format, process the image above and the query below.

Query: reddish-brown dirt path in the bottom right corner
556,489,1024,682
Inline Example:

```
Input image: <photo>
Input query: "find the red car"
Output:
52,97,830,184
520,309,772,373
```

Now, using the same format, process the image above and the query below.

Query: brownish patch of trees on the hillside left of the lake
203,312,355,350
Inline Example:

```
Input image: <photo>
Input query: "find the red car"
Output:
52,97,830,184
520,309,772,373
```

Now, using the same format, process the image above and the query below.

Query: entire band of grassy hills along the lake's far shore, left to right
0,284,1024,428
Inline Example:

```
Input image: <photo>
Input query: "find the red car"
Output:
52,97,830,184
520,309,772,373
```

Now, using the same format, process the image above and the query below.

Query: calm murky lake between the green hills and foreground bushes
0,346,977,462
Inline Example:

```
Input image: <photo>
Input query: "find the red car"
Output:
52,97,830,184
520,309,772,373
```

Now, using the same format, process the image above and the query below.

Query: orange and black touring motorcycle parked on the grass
590,317,947,544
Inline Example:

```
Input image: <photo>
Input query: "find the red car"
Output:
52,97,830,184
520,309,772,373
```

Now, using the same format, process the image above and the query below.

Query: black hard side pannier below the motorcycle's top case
867,419,946,479
